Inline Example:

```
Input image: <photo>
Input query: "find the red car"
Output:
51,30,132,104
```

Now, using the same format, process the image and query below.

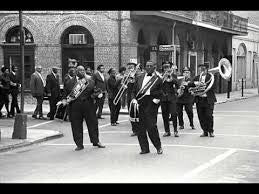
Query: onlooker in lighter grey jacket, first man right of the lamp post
30,65,46,120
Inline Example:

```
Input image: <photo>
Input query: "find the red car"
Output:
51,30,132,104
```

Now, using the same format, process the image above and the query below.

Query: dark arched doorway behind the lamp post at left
2,26,35,91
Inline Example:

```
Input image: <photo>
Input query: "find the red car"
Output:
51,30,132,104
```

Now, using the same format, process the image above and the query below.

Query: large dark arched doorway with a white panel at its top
61,25,94,79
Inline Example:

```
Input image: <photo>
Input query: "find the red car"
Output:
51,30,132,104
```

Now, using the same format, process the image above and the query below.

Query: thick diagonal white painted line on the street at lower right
180,149,236,182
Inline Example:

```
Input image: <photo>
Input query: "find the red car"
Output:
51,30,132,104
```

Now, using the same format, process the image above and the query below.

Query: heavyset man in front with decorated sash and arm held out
58,66,105,151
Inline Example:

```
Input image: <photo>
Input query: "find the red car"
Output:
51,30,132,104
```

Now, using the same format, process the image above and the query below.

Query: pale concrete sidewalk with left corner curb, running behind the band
0,88,259,152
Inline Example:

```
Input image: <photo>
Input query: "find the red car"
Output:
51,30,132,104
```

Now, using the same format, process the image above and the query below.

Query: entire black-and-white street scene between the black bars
0,8,259,184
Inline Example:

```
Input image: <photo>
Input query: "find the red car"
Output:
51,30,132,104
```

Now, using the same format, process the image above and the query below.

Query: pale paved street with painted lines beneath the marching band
0,96,259,183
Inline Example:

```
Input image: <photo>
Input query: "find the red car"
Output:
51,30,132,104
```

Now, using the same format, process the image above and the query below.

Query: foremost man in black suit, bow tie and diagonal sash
133,61,163,154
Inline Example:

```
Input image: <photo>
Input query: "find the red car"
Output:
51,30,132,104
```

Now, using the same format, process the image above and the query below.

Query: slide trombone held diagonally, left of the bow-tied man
113,63,140,105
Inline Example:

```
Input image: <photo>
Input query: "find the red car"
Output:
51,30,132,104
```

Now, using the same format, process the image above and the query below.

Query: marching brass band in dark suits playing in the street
53,58,232,154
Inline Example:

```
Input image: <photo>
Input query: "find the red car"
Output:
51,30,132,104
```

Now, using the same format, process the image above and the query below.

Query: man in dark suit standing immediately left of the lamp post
9,65,21,116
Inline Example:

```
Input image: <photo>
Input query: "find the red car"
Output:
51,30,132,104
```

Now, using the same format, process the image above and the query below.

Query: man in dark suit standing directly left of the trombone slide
107,68,123,126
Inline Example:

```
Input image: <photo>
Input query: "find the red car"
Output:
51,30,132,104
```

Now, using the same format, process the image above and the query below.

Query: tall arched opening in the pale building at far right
236,43,246,80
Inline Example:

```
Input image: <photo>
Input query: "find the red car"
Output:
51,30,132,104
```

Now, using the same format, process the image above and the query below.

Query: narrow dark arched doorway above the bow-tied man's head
137,29,150,66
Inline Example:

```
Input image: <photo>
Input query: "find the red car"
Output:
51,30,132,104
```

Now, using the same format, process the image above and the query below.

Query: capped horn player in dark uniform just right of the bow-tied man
161,62,179,137
